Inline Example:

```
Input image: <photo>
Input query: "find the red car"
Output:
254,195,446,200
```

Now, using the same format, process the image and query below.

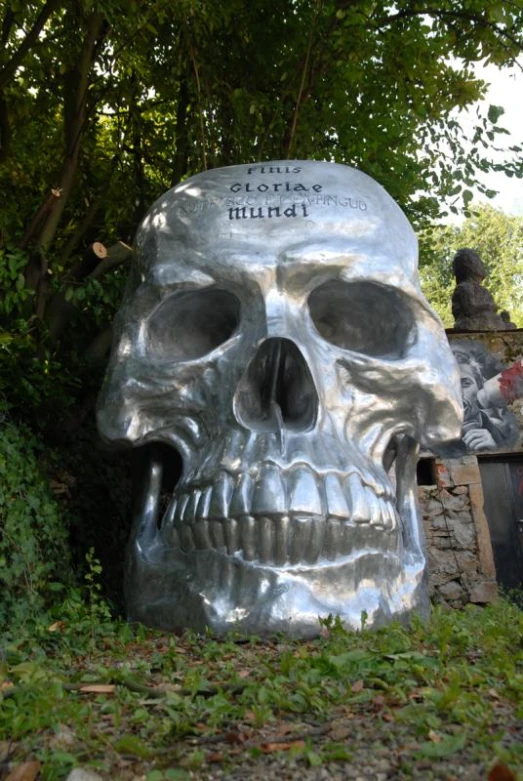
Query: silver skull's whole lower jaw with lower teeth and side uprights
125,436,428,637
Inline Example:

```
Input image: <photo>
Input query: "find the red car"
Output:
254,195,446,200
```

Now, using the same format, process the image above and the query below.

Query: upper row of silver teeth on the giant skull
162,465,397,530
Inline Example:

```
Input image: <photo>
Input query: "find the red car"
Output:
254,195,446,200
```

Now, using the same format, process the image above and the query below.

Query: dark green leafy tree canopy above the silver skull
0,0,523,260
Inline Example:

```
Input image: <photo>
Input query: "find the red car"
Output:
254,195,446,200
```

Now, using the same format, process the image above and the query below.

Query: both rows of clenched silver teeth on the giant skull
161,465,398,567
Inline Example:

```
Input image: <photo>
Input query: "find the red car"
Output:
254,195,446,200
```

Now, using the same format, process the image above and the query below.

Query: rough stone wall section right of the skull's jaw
418,456,497,607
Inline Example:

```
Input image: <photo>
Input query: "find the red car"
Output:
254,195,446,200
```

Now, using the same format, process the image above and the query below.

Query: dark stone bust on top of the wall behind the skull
452,248,510,331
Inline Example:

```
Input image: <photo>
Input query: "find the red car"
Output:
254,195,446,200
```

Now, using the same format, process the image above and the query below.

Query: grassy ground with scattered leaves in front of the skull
0,599,523,781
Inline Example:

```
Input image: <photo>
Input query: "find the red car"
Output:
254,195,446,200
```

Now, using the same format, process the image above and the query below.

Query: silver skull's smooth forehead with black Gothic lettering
136,161,419,297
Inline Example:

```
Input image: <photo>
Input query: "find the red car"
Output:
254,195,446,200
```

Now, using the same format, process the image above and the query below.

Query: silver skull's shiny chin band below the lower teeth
126,551,428,638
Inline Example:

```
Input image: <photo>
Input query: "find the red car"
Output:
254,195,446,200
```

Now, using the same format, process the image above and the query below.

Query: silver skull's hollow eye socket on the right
309,281,414,358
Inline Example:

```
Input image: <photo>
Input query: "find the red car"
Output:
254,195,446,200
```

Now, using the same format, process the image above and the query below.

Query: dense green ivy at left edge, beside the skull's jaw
0,415,72,634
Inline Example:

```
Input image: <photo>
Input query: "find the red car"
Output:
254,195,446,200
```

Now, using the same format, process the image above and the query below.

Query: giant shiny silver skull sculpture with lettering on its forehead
98,161,461,636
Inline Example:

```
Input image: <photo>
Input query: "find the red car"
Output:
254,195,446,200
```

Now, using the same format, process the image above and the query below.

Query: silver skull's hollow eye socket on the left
145,288,241,361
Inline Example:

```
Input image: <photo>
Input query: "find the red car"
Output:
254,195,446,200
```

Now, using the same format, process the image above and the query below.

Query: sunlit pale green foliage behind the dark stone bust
420,205,523,328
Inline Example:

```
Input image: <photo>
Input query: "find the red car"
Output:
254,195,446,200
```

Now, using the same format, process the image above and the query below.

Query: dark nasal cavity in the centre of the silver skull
234,338,318,431
